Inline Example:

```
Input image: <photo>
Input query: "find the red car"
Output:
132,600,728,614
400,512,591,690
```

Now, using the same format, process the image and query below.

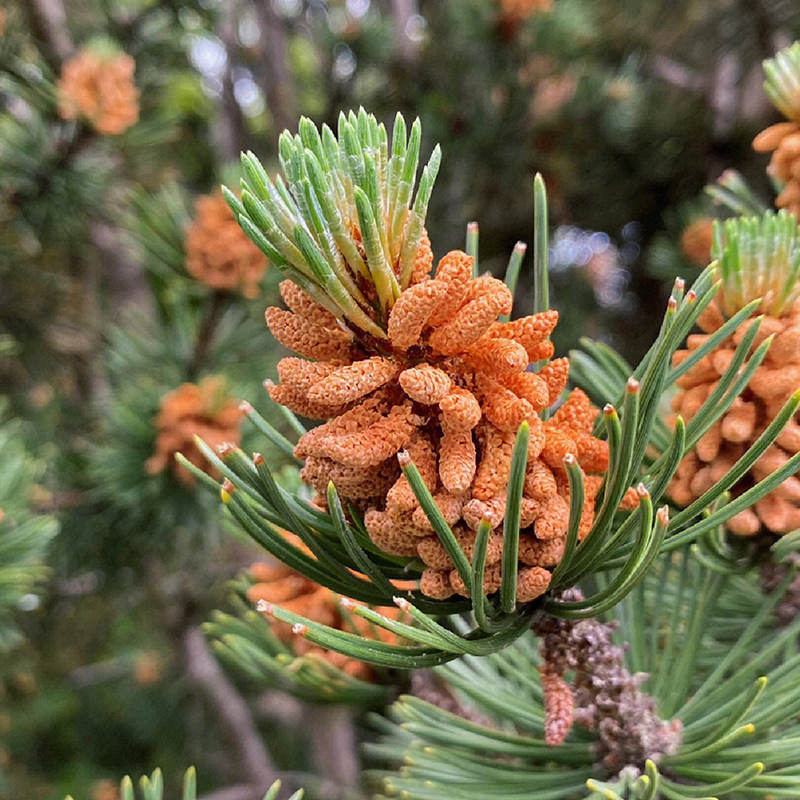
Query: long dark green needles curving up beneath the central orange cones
183,255,800,669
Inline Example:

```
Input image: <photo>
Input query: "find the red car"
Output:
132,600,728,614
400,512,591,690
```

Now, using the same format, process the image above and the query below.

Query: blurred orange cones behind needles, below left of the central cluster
247,560,402,680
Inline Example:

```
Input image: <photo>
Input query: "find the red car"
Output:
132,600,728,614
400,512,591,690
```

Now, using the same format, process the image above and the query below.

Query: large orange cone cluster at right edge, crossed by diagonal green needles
670,303,800,536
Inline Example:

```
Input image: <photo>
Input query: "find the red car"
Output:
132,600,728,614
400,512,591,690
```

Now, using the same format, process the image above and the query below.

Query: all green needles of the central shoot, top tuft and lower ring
184,113,800,669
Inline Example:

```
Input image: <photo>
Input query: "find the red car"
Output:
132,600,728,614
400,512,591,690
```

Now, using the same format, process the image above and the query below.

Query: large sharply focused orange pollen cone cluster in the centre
266,236,620,602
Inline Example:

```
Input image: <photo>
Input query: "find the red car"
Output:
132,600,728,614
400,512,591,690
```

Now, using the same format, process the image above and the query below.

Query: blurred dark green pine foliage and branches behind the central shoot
0,0,800,800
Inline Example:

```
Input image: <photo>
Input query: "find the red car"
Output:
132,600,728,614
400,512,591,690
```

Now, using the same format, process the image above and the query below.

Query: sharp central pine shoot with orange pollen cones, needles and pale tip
181,110,800,668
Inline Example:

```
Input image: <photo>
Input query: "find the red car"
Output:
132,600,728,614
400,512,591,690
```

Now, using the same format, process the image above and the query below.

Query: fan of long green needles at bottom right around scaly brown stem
367,550,800,800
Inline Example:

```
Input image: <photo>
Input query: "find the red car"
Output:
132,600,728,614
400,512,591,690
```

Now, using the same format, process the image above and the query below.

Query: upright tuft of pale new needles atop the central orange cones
223,108,441,339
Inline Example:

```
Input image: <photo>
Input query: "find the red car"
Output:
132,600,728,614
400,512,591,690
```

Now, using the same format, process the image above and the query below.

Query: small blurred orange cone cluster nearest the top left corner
58,50,139,134
